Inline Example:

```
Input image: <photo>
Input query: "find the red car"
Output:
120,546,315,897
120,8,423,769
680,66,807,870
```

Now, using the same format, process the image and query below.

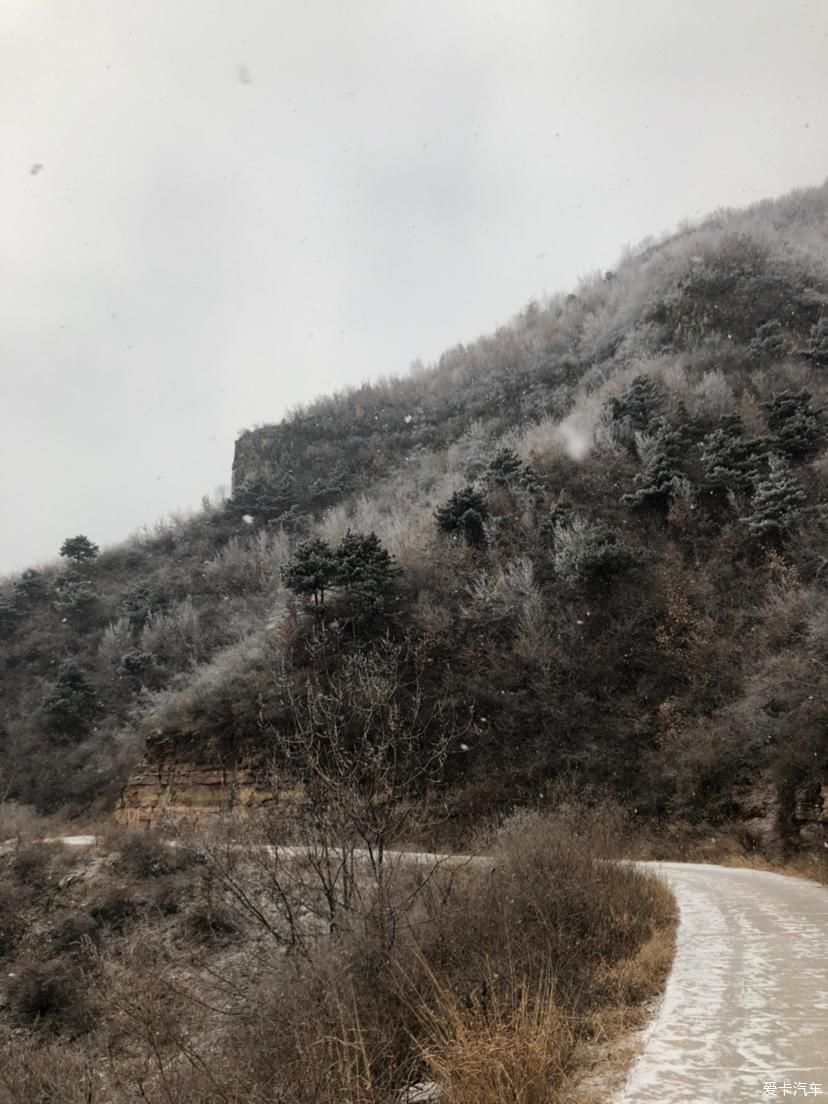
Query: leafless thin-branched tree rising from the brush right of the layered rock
189,635,473,956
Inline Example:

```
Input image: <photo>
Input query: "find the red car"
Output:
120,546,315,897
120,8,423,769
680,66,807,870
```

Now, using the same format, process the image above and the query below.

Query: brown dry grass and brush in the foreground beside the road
0,803,673,1104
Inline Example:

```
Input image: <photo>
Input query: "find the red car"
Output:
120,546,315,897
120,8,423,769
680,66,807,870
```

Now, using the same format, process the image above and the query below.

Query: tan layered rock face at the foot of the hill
115,762,289,827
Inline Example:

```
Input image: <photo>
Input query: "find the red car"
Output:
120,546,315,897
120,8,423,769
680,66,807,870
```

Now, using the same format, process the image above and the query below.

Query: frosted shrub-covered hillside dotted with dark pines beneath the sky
0,184,828,847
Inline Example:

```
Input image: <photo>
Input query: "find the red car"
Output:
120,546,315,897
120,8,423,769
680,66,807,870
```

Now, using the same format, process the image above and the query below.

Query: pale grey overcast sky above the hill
0,0,828,572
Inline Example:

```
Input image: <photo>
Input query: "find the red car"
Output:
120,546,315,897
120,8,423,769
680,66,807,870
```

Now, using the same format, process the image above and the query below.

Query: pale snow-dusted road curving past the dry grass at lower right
617,862,828,1104
